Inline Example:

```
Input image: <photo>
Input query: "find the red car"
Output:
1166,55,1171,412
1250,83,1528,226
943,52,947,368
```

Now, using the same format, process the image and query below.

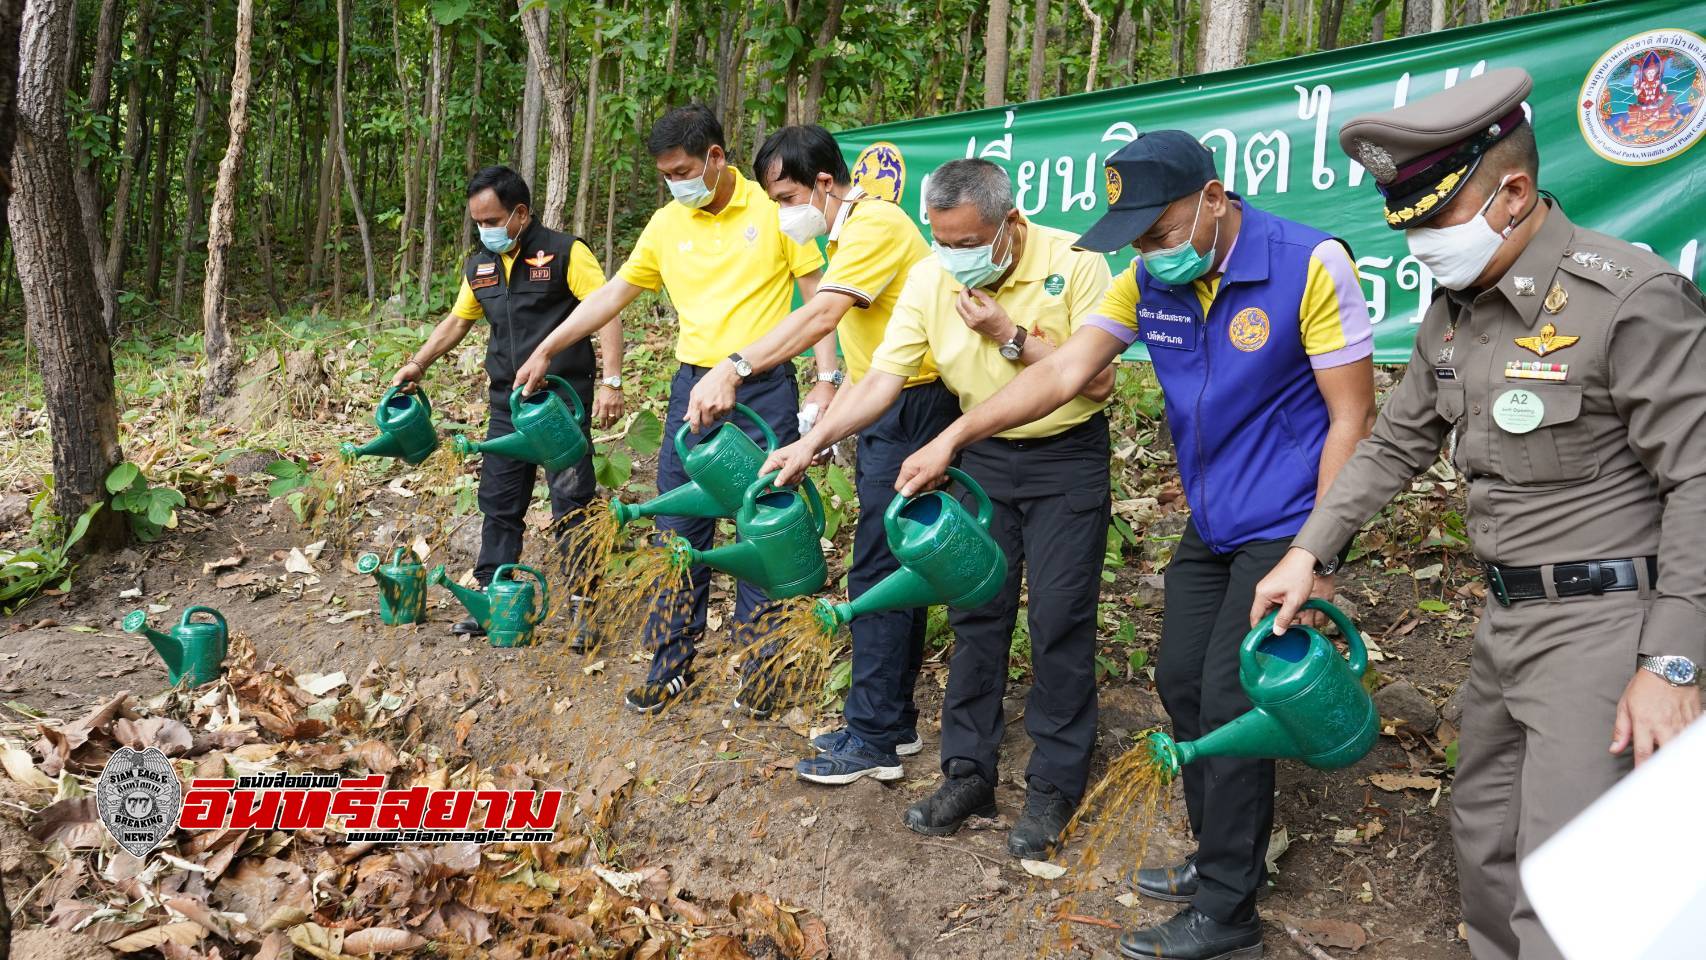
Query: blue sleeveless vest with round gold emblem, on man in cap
1136,194,1329,552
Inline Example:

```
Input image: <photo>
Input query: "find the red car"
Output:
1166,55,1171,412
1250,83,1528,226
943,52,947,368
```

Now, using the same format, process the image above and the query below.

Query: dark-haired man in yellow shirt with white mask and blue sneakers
688,124,959,784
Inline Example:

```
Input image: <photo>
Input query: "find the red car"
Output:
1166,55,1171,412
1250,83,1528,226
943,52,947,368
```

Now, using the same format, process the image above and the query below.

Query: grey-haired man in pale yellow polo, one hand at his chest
764,159,1114,859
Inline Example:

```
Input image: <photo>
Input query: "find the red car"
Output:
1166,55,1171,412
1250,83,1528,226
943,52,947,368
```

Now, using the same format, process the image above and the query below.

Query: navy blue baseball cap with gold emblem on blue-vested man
1073,130,1220,254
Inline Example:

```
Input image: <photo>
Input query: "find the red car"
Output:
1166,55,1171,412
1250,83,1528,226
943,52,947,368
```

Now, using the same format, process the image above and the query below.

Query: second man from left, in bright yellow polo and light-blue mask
517,104,836,713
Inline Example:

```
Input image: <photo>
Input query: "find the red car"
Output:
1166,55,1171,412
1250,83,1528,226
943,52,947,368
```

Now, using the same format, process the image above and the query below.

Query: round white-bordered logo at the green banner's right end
1576,29,1706,167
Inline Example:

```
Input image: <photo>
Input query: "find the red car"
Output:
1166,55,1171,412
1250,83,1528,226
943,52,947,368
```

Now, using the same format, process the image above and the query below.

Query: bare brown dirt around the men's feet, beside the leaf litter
0,480,1469,960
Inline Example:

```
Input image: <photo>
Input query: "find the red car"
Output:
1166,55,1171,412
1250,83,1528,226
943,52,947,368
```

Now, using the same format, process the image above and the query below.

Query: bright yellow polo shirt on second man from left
616,167,824,367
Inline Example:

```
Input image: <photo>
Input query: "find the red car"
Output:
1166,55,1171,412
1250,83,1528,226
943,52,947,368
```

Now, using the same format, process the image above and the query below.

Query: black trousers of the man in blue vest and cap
1155,522,1291,922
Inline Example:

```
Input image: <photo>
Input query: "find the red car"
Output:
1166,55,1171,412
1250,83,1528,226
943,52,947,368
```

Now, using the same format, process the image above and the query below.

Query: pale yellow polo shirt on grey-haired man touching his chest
870,222,1111,440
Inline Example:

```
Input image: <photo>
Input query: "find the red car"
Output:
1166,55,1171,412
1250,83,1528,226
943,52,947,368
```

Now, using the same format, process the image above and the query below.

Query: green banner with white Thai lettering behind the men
838,0,1706,363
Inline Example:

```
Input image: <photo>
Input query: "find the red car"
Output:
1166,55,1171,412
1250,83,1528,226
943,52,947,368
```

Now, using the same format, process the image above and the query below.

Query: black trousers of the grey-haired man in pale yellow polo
942,414,1109,800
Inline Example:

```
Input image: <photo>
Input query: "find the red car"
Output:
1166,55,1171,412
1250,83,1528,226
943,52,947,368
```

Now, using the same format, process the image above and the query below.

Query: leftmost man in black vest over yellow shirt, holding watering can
392,167,623,646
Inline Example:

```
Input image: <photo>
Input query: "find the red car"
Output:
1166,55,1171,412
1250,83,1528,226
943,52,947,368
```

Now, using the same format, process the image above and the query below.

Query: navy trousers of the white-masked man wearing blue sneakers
843,380,960,750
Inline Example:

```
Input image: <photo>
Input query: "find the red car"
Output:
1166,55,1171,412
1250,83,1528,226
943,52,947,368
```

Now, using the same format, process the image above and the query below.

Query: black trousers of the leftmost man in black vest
474,387,597,585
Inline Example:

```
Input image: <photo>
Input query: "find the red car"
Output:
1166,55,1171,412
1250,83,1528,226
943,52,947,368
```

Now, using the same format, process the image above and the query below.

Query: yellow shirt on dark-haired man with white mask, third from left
817,188,937,387
